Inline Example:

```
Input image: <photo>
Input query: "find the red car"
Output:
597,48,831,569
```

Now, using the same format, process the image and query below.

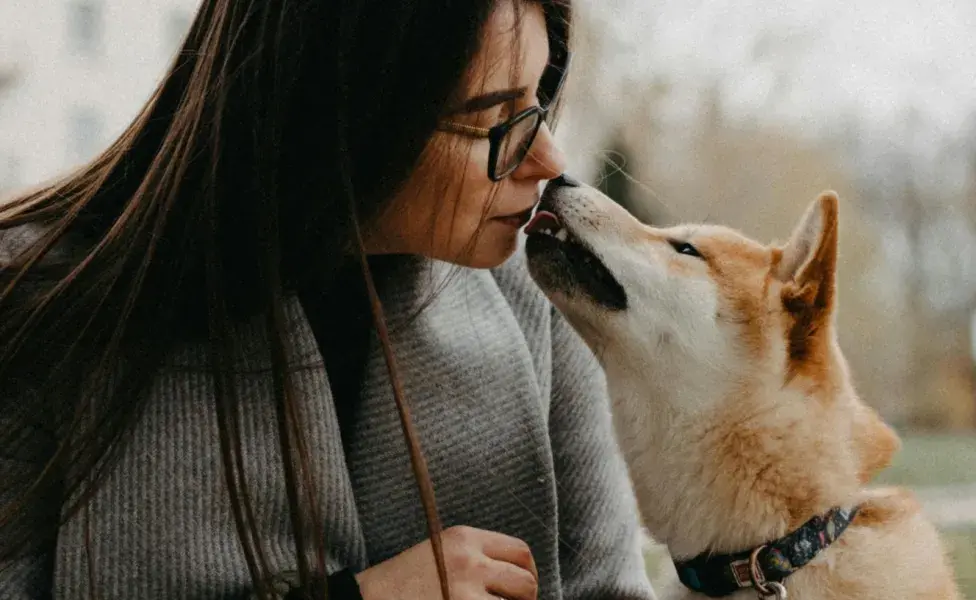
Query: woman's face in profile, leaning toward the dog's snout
364,0,565,268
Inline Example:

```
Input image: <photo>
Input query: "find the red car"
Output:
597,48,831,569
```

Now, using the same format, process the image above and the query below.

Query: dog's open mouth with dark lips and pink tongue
525,209,627,310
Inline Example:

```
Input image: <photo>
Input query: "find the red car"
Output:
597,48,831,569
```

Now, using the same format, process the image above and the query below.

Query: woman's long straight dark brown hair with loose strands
0,0,569,596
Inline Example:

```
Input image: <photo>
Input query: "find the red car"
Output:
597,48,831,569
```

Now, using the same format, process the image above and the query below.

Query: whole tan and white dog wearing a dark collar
526,178,960,600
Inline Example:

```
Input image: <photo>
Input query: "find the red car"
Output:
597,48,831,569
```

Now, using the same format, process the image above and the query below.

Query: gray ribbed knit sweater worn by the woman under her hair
0,245,653,600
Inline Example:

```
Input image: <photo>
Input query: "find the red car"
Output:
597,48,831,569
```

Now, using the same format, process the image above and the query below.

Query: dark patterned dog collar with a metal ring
674,507,858,598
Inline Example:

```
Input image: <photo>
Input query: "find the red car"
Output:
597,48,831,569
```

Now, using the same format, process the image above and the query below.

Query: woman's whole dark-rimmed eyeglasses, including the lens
438,51,572,181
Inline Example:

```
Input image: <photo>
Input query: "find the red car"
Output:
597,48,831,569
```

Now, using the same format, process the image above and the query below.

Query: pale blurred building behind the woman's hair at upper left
0,0,198,192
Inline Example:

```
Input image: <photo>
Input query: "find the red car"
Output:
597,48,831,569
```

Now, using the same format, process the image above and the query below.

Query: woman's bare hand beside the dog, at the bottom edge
356,526,539,600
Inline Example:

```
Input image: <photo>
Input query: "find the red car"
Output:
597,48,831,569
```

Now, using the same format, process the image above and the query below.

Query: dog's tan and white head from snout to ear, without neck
526,176,837,374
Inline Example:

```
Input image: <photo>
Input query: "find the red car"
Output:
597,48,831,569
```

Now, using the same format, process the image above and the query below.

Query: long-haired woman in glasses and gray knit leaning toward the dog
0,0,652,600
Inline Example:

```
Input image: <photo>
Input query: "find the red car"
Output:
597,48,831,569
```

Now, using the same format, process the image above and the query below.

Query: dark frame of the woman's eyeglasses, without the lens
437,51,573,182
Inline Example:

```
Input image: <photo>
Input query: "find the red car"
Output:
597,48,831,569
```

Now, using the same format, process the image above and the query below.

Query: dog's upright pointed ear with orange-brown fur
773,192,838,317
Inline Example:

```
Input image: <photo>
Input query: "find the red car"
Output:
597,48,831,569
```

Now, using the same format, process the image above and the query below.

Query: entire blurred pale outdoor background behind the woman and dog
0,0,976,599
